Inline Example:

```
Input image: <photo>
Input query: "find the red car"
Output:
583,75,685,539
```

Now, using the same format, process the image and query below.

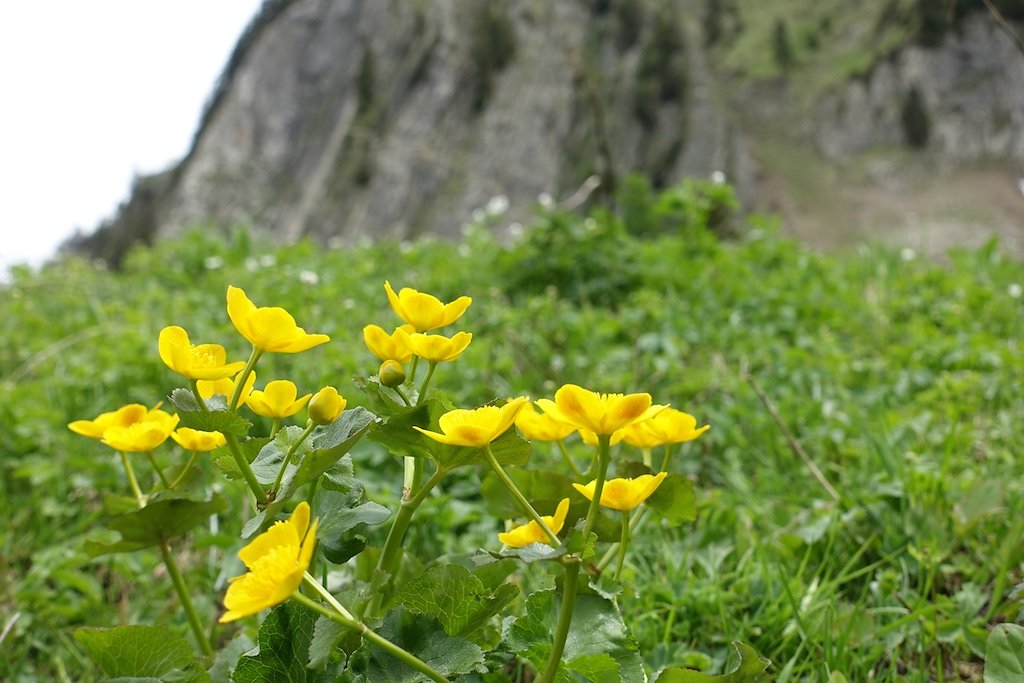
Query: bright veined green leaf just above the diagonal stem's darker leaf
396,564,519,640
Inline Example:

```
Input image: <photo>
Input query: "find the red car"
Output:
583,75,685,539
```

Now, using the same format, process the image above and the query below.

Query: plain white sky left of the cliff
0,0,260,272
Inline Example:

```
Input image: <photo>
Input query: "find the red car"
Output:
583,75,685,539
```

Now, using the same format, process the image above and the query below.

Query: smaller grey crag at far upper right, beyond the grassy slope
813,13,1024,163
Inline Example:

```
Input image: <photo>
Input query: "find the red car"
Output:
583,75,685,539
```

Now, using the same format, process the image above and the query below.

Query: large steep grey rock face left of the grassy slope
159,0,741,245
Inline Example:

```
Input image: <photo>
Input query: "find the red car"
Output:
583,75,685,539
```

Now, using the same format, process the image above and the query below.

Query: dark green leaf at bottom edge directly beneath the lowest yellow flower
231,602,332,683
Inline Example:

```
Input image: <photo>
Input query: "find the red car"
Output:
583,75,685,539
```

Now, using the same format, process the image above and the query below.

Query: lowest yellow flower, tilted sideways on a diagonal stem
220,501,318,624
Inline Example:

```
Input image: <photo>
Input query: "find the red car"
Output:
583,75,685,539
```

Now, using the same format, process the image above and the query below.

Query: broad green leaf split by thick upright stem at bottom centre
505,591,646,683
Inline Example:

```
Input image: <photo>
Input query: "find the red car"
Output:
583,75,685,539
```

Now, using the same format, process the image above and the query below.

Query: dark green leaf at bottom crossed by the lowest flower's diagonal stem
349,607,486,683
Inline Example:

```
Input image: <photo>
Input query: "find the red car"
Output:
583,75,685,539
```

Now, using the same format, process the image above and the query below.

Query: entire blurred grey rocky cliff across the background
72,0,1024,260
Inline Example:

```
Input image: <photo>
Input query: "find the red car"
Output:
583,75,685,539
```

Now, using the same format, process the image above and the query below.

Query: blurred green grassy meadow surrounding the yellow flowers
0,201,1024,681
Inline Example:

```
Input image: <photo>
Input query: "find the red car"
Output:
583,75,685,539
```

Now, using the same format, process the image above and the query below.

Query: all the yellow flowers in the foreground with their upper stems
69,282,709,663
